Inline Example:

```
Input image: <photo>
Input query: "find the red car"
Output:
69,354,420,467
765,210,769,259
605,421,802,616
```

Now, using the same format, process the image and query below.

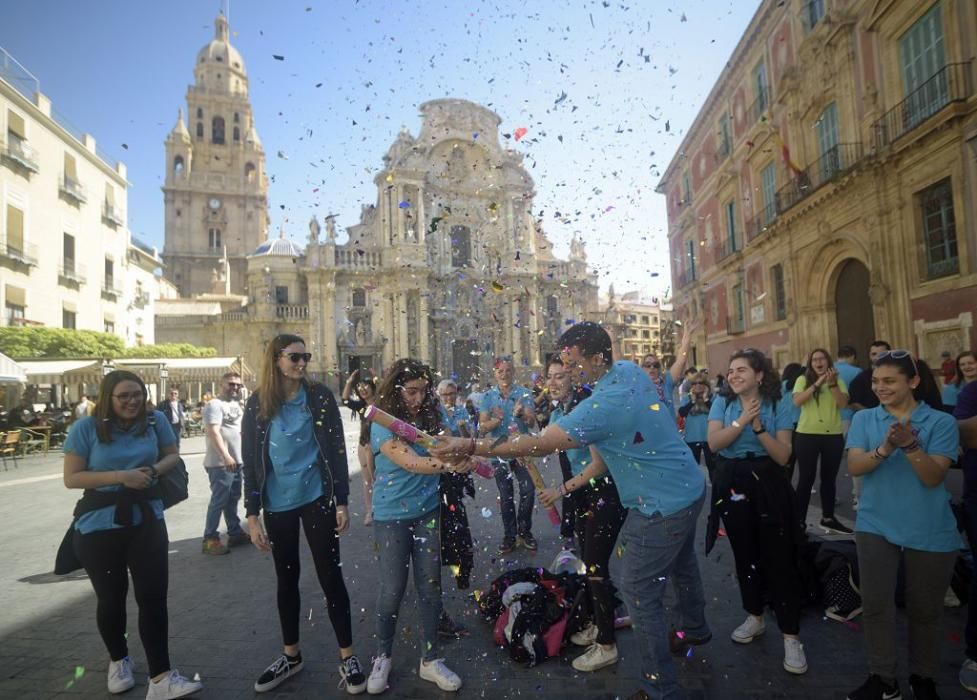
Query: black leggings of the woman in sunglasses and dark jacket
265,497,353,649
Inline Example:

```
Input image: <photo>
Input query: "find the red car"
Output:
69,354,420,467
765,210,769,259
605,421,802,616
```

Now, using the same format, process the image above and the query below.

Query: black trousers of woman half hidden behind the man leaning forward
573,474,627,644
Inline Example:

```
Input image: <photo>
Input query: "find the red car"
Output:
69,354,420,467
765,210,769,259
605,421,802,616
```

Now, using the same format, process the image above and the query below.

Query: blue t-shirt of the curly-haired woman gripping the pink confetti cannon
370,423,441,522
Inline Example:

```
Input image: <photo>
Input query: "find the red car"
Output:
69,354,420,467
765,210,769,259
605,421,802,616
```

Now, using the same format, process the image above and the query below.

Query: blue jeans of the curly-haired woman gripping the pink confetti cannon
373,508,441,661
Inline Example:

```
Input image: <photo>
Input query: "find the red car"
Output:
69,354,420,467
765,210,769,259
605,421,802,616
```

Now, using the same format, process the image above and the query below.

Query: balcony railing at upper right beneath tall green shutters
872,62,974,148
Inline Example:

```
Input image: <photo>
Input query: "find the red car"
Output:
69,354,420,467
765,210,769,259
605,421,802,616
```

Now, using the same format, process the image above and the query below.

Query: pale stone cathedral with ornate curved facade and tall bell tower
157,18,597,387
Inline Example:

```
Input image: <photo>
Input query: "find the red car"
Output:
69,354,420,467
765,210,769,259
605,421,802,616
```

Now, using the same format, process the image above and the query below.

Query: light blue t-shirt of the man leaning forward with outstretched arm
557,361,705,517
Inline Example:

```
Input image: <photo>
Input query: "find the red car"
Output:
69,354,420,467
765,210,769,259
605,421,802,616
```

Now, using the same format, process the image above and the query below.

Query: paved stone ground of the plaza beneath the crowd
0,423,967,700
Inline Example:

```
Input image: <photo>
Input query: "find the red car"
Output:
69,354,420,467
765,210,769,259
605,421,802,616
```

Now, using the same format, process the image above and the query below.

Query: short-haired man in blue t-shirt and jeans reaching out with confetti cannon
432,323,712,698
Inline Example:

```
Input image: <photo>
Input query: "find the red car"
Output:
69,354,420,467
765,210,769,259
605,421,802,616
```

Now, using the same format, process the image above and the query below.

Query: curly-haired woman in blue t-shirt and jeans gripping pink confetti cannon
367,359,470,695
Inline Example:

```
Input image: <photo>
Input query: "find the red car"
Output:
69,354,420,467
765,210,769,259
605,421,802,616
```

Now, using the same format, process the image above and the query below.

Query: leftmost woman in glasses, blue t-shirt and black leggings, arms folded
64,370,202,700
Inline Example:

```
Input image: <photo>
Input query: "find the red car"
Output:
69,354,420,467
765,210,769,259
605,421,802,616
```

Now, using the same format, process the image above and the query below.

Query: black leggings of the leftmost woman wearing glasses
74,519,170,677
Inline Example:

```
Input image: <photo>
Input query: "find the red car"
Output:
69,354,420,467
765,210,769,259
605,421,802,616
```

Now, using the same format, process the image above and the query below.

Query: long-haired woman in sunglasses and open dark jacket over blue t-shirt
241,334,366,695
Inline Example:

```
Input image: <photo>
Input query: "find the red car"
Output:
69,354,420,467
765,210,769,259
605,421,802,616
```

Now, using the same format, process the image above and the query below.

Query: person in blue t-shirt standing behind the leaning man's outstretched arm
478,357,537,555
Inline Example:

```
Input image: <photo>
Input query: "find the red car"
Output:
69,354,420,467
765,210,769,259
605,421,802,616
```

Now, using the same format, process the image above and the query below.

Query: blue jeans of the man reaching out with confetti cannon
620,493,710,700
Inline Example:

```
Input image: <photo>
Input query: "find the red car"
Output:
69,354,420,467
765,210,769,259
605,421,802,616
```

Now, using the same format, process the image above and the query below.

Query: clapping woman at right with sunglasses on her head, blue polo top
847,350,961,700
